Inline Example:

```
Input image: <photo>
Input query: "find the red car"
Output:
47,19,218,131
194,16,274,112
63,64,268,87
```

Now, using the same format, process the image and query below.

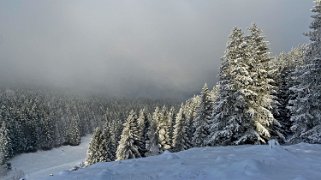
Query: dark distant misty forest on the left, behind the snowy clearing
0,88,175,165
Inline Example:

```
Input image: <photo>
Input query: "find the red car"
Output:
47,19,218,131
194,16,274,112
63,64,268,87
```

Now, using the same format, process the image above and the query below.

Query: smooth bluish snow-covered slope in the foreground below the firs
46,143,321,180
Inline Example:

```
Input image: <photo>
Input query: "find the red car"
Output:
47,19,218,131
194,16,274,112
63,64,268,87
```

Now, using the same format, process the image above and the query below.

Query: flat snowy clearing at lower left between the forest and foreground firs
0,135,91,180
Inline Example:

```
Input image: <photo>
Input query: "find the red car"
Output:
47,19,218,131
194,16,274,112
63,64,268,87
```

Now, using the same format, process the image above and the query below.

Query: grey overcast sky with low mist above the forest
0,0,313,97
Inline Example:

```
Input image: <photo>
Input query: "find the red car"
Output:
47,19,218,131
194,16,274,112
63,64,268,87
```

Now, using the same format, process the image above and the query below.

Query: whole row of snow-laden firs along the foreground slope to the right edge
86,1,321,165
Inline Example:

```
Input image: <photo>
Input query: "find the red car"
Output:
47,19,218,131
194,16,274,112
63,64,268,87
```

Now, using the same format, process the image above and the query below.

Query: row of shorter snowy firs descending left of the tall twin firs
86,85,218,165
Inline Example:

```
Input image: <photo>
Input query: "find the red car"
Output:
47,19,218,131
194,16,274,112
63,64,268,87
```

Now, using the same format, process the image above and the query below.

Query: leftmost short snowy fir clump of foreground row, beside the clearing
85,128,115,165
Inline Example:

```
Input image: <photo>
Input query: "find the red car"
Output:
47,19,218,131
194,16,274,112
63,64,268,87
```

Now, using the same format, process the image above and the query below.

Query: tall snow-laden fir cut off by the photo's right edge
289,0,321,143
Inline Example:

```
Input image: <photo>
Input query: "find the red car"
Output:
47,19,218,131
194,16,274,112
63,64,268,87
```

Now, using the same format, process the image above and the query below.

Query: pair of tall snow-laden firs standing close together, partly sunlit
207,24,282,145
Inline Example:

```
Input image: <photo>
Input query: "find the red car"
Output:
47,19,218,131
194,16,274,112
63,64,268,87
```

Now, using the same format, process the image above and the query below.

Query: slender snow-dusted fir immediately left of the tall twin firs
193,84,213,147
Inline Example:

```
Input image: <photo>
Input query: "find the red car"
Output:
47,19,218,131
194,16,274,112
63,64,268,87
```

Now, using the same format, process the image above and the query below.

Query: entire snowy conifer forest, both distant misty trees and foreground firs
0,1,321,176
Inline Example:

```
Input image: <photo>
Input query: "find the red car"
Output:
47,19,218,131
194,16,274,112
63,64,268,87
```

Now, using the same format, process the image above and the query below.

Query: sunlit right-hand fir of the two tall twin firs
247,24,283,143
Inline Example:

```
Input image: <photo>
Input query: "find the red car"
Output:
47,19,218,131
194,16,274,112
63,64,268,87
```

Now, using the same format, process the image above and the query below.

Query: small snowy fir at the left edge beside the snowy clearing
0,121,13,165
